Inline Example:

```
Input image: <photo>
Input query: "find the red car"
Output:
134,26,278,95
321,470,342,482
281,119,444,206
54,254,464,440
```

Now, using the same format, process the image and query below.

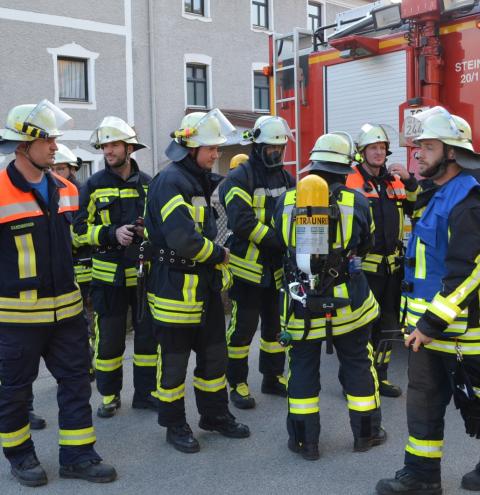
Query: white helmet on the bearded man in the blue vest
413,106,475,153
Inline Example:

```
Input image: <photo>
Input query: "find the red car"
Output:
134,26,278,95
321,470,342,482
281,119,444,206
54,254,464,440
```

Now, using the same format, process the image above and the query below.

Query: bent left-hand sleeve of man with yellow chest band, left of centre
73,181,119,246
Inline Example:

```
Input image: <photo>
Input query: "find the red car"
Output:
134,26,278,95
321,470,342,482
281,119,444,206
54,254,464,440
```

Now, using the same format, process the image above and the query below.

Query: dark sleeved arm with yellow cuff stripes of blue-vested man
417,205,480,337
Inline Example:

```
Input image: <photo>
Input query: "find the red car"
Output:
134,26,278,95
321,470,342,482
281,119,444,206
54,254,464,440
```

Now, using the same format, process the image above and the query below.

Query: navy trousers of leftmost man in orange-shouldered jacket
0,315,100,465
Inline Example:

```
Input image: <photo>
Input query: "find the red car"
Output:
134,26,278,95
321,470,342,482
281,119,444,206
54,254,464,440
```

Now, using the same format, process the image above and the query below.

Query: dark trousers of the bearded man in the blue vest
405,347,480,483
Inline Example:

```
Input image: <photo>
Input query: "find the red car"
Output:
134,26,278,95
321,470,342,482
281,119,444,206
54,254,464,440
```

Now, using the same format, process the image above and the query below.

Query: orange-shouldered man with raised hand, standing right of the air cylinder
346,124,418,397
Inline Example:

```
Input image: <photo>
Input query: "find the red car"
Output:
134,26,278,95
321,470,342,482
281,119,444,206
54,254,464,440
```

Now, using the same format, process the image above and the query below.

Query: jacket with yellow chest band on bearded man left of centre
73,159,150,287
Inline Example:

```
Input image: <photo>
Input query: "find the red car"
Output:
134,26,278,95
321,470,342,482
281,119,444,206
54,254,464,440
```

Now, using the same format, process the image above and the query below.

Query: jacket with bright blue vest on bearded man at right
402,172,480,354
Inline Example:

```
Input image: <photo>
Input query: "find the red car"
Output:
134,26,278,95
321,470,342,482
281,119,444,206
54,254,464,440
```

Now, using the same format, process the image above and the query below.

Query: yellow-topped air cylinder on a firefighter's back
295,175,329,275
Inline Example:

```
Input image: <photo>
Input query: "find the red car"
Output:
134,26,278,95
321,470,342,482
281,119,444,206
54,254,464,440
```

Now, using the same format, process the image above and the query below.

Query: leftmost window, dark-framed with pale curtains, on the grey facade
58,57,88,101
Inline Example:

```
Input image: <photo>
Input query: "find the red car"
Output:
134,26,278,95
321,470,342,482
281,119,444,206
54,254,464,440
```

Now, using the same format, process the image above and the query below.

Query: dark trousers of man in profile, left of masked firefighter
153,292,228,427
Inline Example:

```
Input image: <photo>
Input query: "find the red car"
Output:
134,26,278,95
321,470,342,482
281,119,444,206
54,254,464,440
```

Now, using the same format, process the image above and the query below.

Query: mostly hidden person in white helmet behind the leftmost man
52,143,95,381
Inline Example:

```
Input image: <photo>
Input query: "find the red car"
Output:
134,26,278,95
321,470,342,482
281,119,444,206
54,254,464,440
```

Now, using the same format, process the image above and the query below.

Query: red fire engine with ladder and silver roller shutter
264,0,480,177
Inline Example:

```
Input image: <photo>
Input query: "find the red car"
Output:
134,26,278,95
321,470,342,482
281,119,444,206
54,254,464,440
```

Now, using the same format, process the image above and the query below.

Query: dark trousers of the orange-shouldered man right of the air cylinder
364,270,402,381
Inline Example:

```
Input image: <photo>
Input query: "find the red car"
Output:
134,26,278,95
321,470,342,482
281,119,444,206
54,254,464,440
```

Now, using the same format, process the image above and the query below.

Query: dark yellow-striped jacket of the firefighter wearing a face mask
220,153,295,289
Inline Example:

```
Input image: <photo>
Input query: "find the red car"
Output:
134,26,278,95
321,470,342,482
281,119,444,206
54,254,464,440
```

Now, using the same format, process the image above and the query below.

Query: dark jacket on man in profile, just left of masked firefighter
145,155,231,327
